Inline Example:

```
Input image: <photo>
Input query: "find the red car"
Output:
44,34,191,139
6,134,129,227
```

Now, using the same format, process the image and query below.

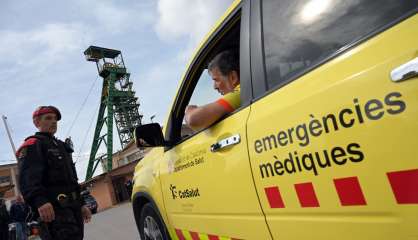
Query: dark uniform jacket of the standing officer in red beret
16,132,80,209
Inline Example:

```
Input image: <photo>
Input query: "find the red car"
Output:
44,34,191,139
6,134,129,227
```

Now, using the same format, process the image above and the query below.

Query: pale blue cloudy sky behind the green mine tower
0,0,232,179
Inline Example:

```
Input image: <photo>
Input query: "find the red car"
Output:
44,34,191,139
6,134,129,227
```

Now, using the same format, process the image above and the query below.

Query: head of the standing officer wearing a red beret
32,106,61,135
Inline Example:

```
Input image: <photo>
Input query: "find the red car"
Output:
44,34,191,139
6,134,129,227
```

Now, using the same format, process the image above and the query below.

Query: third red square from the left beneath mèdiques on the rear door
334,177,367,206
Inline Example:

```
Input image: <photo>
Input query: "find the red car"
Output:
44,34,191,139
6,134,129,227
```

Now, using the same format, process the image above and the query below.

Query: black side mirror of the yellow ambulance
135,123,167,148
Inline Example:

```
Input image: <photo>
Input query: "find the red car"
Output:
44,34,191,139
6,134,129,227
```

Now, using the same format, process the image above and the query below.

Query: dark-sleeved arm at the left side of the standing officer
19,141,48,209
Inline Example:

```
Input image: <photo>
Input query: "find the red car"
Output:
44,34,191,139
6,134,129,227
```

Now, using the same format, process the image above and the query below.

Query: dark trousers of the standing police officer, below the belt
42,206,84,240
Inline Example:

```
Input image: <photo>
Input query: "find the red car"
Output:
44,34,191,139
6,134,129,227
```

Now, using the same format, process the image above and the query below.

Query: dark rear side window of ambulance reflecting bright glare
260,0,417,89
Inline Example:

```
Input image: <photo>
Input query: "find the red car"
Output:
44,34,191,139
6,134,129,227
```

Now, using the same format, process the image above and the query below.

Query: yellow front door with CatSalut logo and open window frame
161,2,271,239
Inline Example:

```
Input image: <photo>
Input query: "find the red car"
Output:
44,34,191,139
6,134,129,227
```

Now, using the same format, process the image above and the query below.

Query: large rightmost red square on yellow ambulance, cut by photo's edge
387,169,418,204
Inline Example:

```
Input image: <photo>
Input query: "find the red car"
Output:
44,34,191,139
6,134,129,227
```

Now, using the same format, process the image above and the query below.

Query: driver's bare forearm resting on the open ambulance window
185,102,228,130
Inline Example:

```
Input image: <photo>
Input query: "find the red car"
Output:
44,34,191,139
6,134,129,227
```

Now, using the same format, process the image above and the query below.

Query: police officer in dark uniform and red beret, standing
16,106,91,240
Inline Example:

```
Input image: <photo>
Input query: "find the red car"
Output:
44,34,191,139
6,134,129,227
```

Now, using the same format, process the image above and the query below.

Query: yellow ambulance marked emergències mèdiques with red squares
132,0,418,240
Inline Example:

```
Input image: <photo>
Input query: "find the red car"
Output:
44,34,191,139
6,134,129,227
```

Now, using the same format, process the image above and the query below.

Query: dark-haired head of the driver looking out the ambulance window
208,50,240,95
